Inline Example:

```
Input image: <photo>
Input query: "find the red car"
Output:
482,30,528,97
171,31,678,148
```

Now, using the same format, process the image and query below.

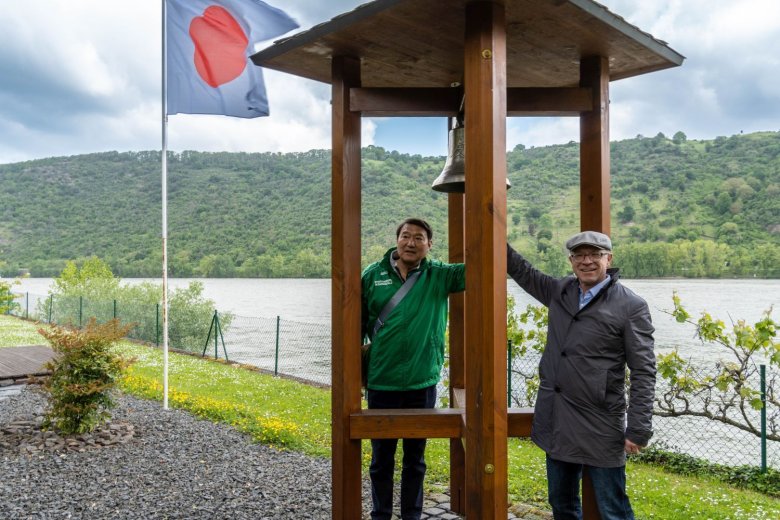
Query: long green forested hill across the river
0,132,780,277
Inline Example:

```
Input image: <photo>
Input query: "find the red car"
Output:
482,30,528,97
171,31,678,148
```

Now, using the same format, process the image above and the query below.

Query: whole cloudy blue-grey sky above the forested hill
0,0,780,163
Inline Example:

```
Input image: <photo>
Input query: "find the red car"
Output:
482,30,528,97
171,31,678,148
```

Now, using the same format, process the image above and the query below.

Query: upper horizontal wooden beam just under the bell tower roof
349,87,593,117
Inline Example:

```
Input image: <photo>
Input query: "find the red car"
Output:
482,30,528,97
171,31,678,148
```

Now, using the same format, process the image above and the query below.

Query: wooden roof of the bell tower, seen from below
252,0,684,87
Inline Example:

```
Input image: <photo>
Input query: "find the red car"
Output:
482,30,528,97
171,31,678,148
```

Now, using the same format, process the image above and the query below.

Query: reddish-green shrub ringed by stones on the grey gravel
39,319,129,435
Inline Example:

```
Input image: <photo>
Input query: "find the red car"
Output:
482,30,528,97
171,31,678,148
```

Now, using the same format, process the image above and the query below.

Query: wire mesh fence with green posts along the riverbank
8,293,780,469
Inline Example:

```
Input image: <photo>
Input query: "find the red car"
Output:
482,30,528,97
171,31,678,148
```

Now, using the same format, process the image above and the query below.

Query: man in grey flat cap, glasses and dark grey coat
507,231,656,520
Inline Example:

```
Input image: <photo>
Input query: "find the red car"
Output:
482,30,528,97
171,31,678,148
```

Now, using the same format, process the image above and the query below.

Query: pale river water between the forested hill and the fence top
14,278,780,361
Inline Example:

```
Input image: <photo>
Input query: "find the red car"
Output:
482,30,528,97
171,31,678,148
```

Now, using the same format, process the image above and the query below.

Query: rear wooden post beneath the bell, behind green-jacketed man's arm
448,193,466,514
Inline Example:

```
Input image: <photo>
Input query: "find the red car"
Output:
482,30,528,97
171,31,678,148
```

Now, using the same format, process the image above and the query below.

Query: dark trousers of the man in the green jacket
366,385,436,520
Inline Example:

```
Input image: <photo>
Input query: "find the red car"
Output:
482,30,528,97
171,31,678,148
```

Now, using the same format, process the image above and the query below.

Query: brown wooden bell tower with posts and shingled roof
253,0,683,520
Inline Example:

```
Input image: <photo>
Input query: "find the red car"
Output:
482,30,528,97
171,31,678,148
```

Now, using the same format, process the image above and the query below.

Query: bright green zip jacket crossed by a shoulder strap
361,248,466,390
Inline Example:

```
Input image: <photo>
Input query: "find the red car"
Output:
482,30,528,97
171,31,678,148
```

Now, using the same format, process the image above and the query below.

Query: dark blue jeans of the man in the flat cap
547,455,634,520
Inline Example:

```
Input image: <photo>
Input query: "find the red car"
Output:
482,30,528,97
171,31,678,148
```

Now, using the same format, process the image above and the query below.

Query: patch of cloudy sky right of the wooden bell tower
610,0,780,139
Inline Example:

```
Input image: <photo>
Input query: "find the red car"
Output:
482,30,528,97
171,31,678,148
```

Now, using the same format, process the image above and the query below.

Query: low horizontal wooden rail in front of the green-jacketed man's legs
349,408,463,439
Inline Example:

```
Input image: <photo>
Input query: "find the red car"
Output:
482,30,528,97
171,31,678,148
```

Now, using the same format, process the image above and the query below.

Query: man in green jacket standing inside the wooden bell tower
362,218,466,520
